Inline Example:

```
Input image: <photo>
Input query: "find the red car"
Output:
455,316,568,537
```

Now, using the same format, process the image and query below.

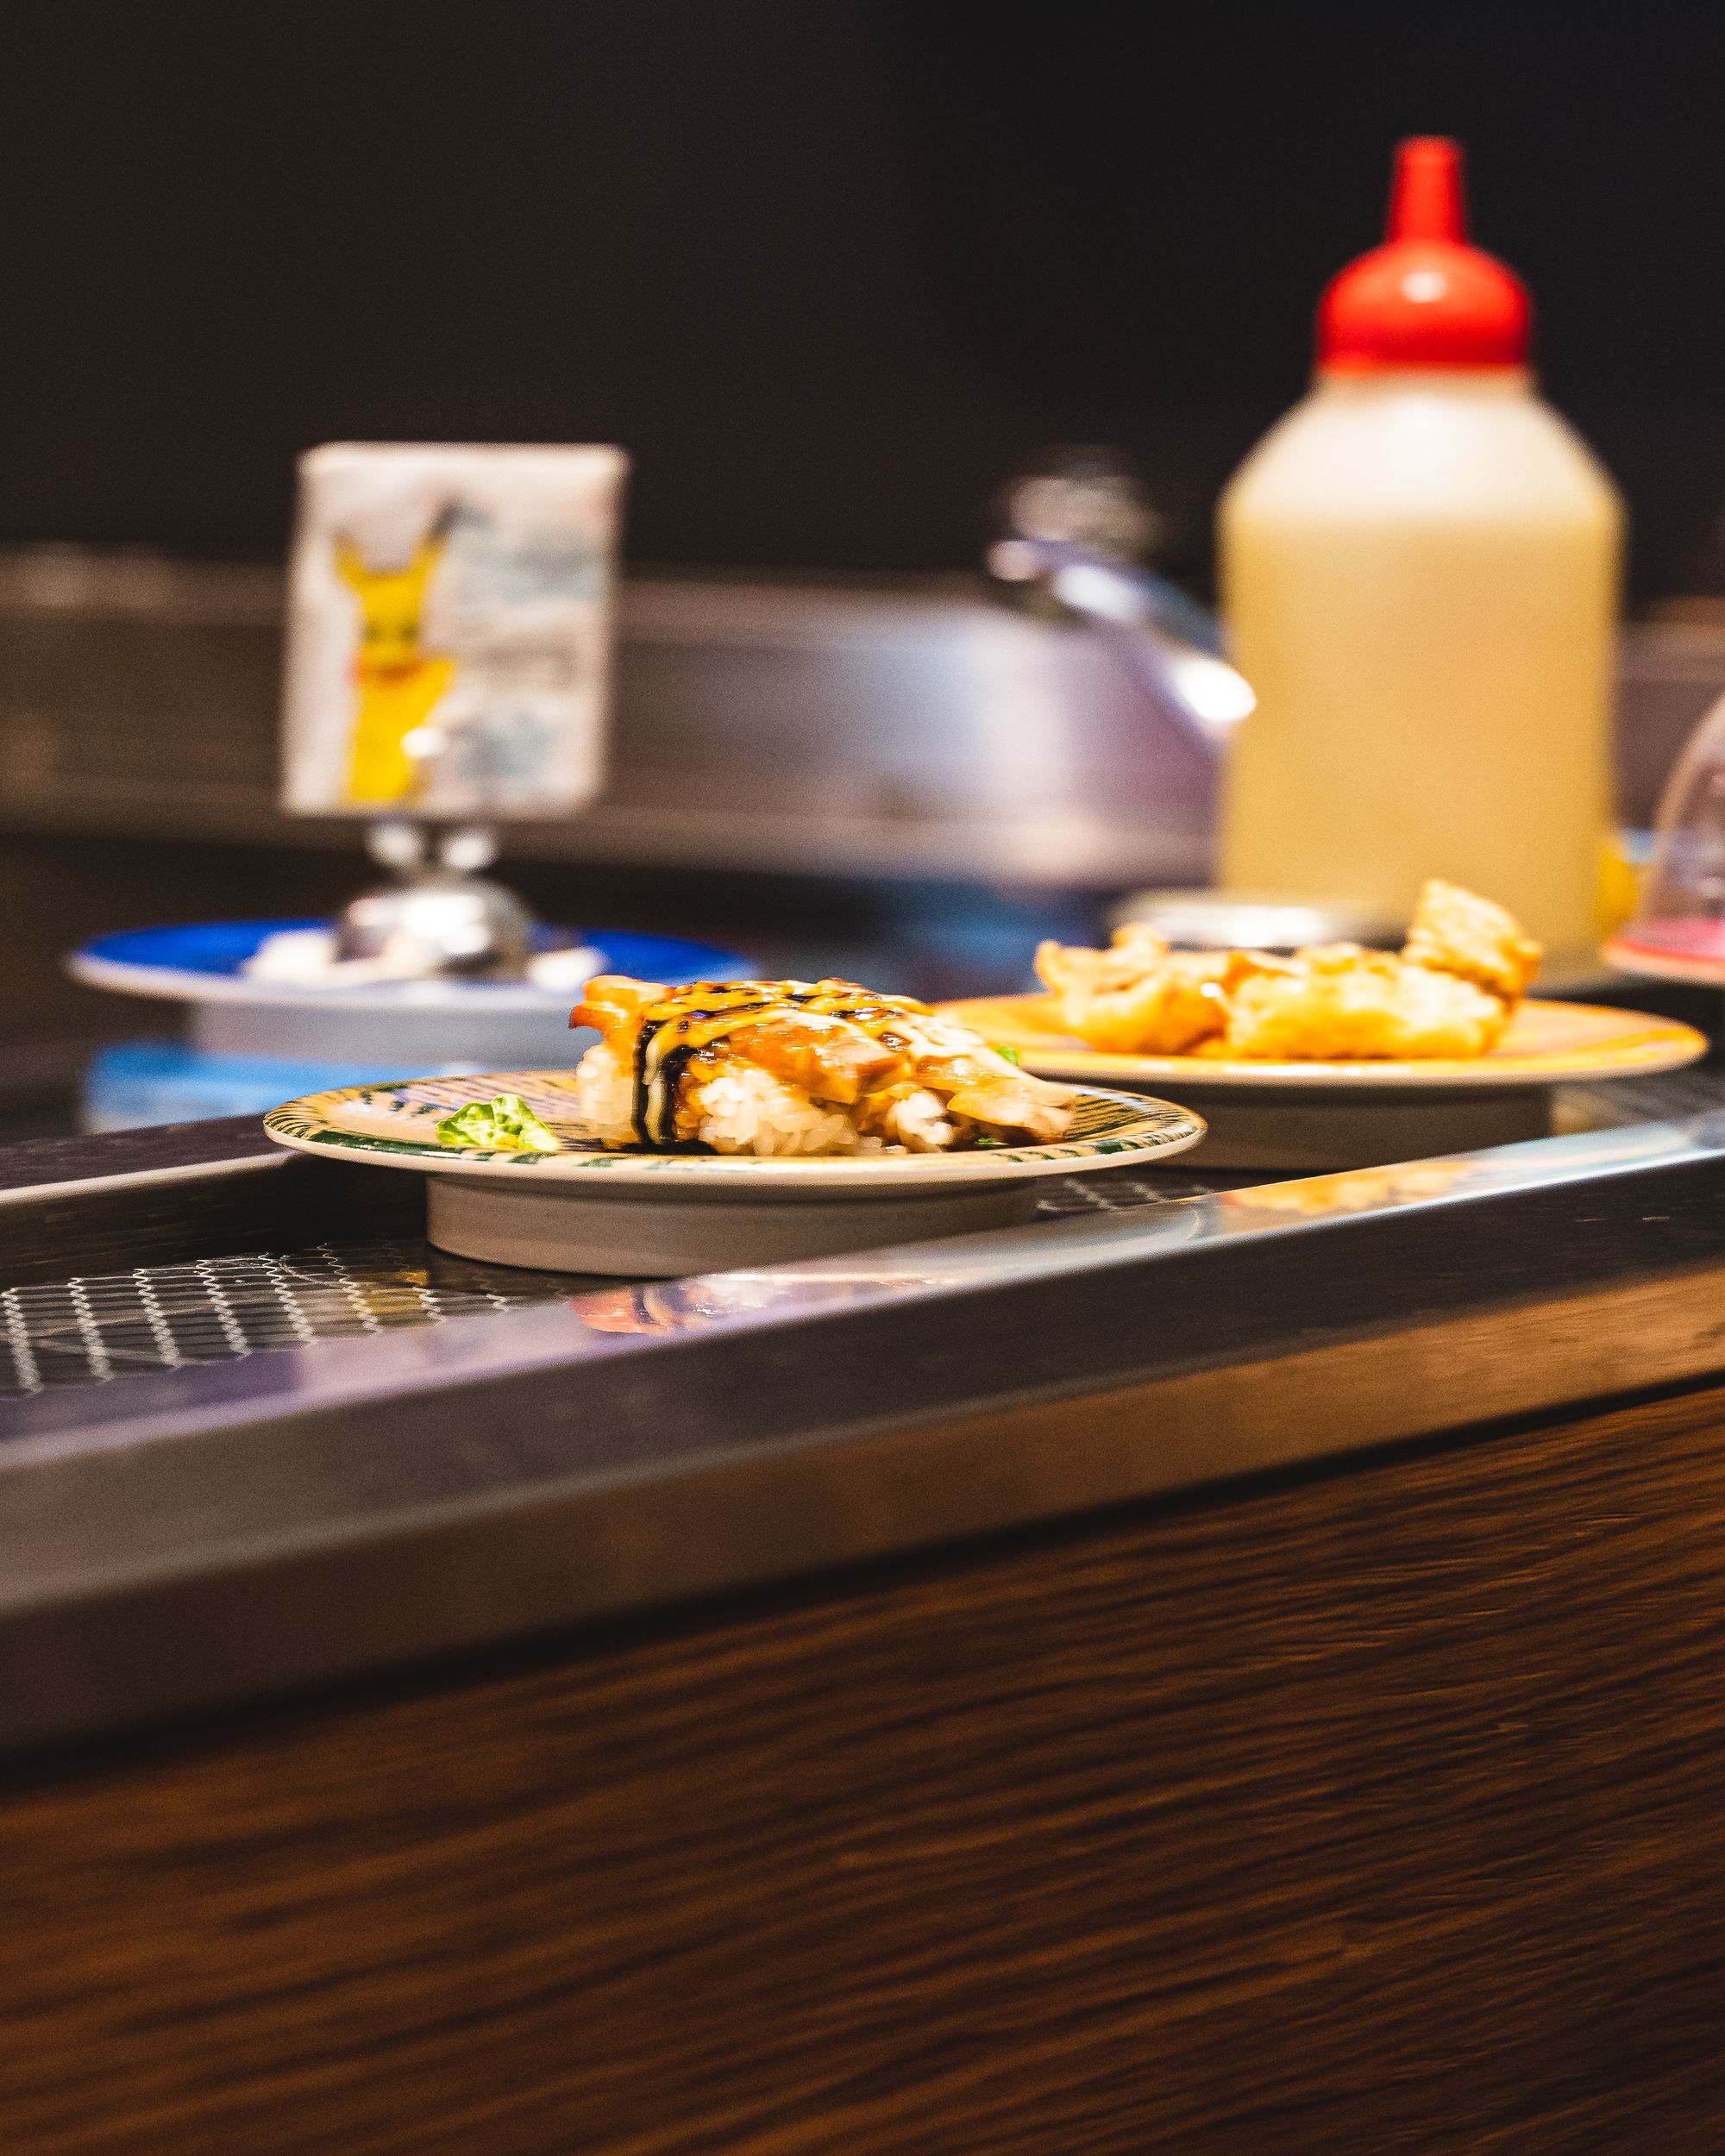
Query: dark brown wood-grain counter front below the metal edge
0,1391,1725,2156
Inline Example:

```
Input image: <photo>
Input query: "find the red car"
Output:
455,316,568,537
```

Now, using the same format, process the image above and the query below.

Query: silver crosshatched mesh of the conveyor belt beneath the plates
0,1175,1219,1397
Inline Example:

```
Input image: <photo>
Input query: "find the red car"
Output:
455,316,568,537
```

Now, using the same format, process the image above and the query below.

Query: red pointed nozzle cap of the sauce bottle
1318,136,1534,375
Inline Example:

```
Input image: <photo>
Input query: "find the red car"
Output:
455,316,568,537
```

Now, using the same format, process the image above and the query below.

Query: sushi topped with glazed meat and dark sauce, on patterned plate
569,975,1076,1156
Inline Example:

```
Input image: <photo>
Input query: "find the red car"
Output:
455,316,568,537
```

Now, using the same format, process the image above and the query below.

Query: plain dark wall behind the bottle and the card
0,0,1725,598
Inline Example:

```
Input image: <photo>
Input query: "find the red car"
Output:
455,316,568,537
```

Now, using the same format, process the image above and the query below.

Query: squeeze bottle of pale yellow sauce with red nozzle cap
1219,138,1622,956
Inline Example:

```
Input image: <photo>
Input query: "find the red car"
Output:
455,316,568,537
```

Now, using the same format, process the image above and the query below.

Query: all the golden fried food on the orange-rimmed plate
1038,880,1540,1063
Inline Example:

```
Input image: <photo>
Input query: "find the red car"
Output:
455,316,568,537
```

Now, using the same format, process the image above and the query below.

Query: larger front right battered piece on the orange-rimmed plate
1220,944,1509,1063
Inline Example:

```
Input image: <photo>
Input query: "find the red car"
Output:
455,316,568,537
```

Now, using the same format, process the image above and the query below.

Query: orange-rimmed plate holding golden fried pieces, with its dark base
947,884,1708,1169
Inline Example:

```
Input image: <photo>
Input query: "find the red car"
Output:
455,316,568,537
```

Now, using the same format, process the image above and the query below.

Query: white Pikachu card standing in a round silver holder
283,442,628,822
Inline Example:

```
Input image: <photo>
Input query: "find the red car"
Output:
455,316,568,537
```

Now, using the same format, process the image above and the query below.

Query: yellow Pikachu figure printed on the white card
335,509,455,806
